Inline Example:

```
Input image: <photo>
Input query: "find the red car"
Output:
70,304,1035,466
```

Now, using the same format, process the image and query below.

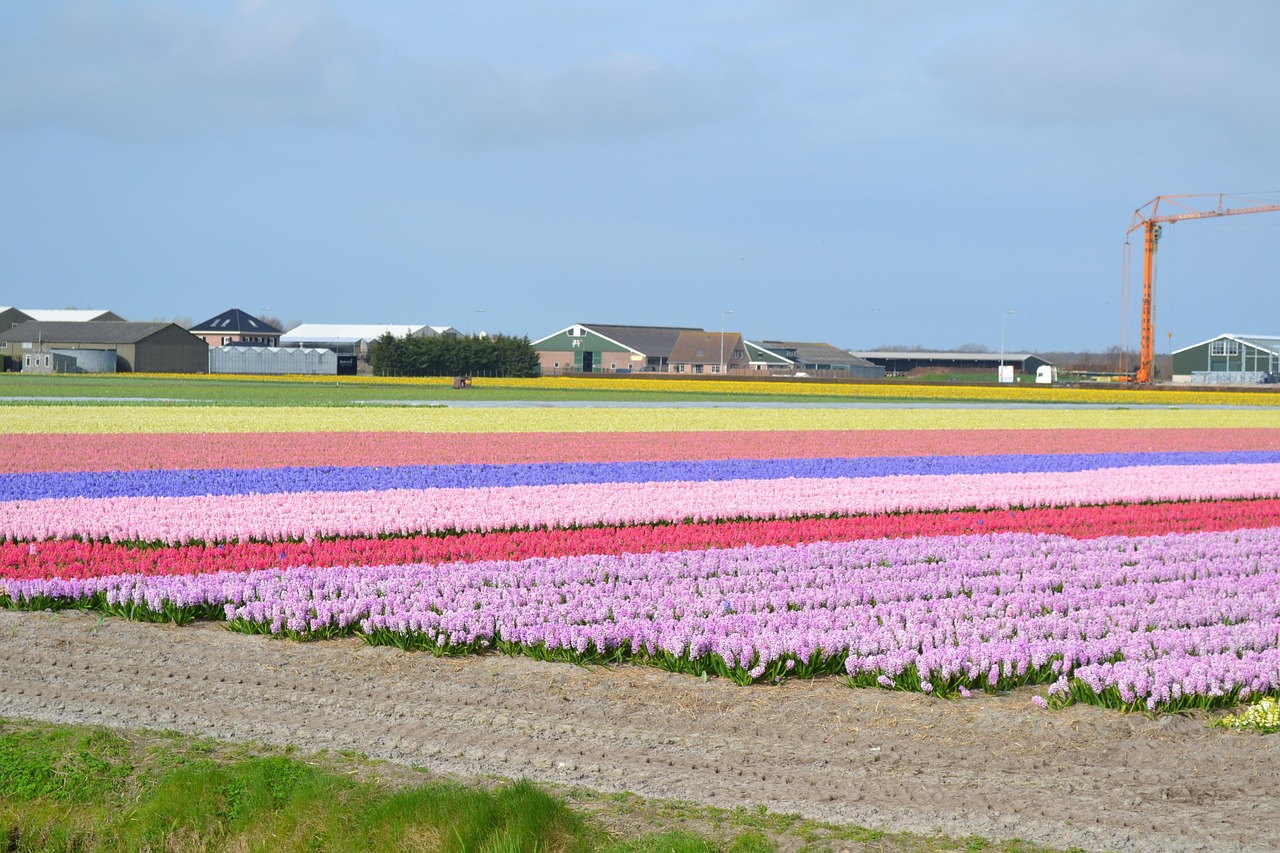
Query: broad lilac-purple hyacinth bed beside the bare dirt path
0,529,1280,707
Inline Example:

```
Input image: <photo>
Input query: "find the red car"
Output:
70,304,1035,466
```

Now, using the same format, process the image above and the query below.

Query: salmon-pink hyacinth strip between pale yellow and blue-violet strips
0,429,1280,474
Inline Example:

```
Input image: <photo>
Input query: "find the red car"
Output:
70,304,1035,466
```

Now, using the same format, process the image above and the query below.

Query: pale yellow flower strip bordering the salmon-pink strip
0,406,1280,432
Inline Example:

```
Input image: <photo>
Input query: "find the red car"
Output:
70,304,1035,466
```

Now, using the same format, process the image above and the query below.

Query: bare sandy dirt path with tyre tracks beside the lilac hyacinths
0,611,1280,852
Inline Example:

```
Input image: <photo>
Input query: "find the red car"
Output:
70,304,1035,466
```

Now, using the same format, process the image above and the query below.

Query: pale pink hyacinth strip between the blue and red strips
0,464,1280,544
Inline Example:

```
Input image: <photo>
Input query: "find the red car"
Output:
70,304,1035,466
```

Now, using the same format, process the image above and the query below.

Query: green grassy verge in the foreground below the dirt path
0,720,1080,853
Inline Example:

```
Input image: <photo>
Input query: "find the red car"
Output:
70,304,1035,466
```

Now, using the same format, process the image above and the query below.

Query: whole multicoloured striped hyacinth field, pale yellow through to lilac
0,400,1280,711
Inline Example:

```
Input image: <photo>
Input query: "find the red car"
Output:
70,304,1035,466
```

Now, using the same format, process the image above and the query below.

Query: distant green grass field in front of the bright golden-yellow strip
0,373,884,406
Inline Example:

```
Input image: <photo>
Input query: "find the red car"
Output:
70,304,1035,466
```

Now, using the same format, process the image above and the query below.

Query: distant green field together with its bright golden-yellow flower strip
0,374,1280,406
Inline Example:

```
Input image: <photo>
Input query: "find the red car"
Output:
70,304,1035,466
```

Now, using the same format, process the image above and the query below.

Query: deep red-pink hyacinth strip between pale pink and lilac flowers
0,500,1280,580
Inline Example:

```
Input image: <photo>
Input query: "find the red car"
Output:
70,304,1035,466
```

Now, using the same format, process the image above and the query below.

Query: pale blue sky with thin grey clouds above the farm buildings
0,0,1280,352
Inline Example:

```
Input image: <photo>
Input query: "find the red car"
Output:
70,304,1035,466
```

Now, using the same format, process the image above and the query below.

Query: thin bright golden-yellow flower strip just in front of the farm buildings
64,373,1280,406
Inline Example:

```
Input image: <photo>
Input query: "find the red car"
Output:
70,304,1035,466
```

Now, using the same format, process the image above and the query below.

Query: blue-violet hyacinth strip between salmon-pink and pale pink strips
0,451,1280,501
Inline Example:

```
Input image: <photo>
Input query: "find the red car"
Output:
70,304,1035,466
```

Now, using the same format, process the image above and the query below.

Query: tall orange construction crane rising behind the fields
1120,192,1280,383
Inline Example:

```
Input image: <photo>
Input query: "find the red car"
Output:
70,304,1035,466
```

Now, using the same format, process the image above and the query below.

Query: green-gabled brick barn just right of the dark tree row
532,323,718,377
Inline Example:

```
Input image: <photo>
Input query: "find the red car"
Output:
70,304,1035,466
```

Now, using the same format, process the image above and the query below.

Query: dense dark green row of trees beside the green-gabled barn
369,334,540,377
